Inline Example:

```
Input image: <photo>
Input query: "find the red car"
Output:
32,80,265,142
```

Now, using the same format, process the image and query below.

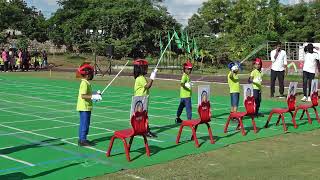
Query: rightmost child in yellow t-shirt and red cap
249,58,264,117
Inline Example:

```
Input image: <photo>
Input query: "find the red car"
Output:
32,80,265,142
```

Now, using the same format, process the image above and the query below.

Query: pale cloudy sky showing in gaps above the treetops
26,0,288,26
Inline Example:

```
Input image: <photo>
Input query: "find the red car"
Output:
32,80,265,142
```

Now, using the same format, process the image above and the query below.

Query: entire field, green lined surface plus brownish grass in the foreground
0,72,320,179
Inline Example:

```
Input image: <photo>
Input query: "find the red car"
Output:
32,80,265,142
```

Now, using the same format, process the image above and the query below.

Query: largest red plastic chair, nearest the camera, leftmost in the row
106,111,150,161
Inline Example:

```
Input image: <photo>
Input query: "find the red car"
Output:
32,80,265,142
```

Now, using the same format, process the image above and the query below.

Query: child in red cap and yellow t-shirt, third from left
176,60,192,124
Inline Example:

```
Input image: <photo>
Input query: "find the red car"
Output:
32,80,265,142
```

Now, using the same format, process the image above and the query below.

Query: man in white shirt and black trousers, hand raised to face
270,42,287,98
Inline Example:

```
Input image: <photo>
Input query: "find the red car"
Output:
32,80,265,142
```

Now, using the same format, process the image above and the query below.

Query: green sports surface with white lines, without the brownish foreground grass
0,73,320,179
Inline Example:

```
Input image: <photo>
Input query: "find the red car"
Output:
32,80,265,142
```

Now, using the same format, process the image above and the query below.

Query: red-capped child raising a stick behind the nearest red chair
133,59,157,137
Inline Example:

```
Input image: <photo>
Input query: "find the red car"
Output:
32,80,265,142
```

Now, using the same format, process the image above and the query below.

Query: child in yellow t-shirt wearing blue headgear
228,62,240,113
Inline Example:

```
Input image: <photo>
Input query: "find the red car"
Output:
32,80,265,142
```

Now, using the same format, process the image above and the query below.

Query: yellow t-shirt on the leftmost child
77,79,92,111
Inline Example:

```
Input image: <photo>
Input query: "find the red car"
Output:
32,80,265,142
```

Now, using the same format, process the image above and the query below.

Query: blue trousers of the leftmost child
79,111,91,142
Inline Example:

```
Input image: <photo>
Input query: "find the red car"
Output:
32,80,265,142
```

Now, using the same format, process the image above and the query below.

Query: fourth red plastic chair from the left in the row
264,95,297,131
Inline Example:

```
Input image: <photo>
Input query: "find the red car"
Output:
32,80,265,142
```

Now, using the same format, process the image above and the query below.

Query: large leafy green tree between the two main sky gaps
49,0,179,58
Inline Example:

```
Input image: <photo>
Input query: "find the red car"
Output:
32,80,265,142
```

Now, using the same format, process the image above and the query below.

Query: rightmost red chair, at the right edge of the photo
294,92,320,124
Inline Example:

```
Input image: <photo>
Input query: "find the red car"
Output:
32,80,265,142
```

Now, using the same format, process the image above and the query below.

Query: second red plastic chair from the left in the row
176,101,214,148
